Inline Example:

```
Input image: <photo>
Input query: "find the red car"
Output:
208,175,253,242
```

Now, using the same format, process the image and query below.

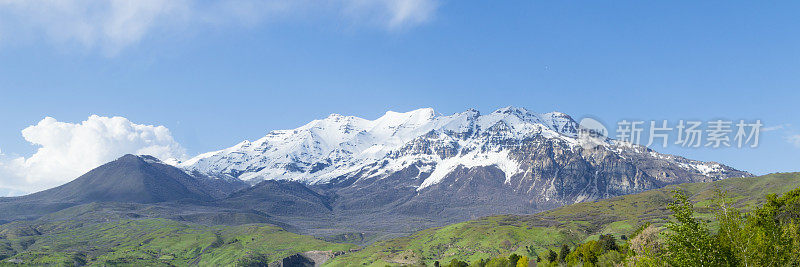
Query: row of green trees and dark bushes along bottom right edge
422,188,800,267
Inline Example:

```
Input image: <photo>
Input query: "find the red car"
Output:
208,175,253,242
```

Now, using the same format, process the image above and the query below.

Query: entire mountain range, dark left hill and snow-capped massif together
0,107,751,240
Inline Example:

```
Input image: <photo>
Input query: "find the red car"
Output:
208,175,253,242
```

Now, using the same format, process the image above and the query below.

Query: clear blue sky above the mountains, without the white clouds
0,0,800,195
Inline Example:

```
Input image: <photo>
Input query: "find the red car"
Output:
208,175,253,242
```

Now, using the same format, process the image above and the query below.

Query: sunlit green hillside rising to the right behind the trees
326,173,800,266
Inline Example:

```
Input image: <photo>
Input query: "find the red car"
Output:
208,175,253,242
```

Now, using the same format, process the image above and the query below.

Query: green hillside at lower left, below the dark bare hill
0,219,353,266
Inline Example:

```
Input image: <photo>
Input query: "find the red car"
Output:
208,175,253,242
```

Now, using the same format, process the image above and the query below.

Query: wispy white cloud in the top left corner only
0,0,189,54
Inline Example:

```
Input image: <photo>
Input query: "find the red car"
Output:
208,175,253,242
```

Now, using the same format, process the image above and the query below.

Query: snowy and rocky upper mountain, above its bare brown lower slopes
179,107,750,206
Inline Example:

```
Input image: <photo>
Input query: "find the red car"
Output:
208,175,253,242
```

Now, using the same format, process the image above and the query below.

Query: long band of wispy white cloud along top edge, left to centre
0,0,439,55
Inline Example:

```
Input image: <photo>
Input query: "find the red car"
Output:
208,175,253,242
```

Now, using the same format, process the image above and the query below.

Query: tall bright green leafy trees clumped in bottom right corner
664,188,800,266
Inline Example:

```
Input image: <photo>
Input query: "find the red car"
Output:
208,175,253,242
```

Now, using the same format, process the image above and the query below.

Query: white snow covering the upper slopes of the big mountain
179,107,748,190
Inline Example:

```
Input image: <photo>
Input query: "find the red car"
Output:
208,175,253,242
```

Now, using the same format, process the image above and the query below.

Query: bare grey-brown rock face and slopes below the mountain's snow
316,133,750,228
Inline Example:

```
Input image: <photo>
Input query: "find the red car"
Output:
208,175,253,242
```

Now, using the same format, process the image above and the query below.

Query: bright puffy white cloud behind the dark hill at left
0,115,186,193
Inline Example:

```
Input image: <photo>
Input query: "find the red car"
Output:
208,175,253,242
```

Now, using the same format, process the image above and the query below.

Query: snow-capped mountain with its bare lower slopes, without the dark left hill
179,107,750,228
